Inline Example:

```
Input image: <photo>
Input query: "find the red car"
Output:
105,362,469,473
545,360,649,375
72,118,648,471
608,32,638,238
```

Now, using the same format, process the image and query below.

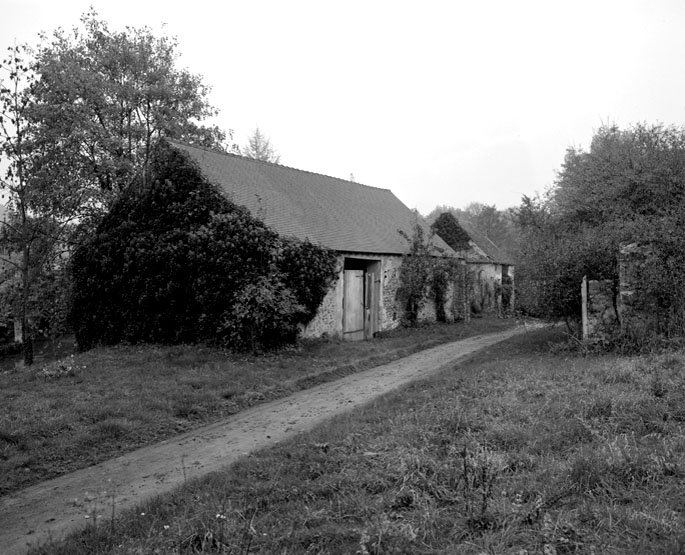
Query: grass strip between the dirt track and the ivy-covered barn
0,318,514,495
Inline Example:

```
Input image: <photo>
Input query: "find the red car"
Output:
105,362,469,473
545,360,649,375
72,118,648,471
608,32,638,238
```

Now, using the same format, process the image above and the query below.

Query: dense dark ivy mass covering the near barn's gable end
71,145,335,350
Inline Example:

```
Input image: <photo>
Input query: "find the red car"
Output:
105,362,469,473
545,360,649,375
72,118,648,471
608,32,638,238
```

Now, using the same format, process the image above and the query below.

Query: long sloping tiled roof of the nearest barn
169,141,455,256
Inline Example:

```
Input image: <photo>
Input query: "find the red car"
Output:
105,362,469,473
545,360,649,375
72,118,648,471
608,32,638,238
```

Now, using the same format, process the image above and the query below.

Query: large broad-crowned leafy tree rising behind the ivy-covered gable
34,9,226,208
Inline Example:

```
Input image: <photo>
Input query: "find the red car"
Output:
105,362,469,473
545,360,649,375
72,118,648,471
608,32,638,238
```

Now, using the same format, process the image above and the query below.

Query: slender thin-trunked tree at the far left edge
0,46,88,365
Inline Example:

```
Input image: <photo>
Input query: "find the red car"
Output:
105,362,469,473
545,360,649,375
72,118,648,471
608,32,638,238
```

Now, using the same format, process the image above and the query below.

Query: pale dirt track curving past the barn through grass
0,327,524,555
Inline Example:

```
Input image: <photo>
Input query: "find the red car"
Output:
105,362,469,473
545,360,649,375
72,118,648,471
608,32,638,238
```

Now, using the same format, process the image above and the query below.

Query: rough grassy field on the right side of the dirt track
26,331,685,555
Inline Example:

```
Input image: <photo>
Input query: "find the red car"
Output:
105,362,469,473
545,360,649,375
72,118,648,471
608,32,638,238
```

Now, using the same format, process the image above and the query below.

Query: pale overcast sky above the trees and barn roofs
0,0,685,214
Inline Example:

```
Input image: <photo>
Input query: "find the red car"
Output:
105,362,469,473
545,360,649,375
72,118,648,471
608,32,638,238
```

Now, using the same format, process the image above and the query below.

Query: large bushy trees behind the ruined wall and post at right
516,124,685,344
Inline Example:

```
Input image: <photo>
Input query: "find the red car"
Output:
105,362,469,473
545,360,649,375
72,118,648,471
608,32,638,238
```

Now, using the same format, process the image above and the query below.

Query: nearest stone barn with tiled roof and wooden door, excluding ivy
169,141,459,340
